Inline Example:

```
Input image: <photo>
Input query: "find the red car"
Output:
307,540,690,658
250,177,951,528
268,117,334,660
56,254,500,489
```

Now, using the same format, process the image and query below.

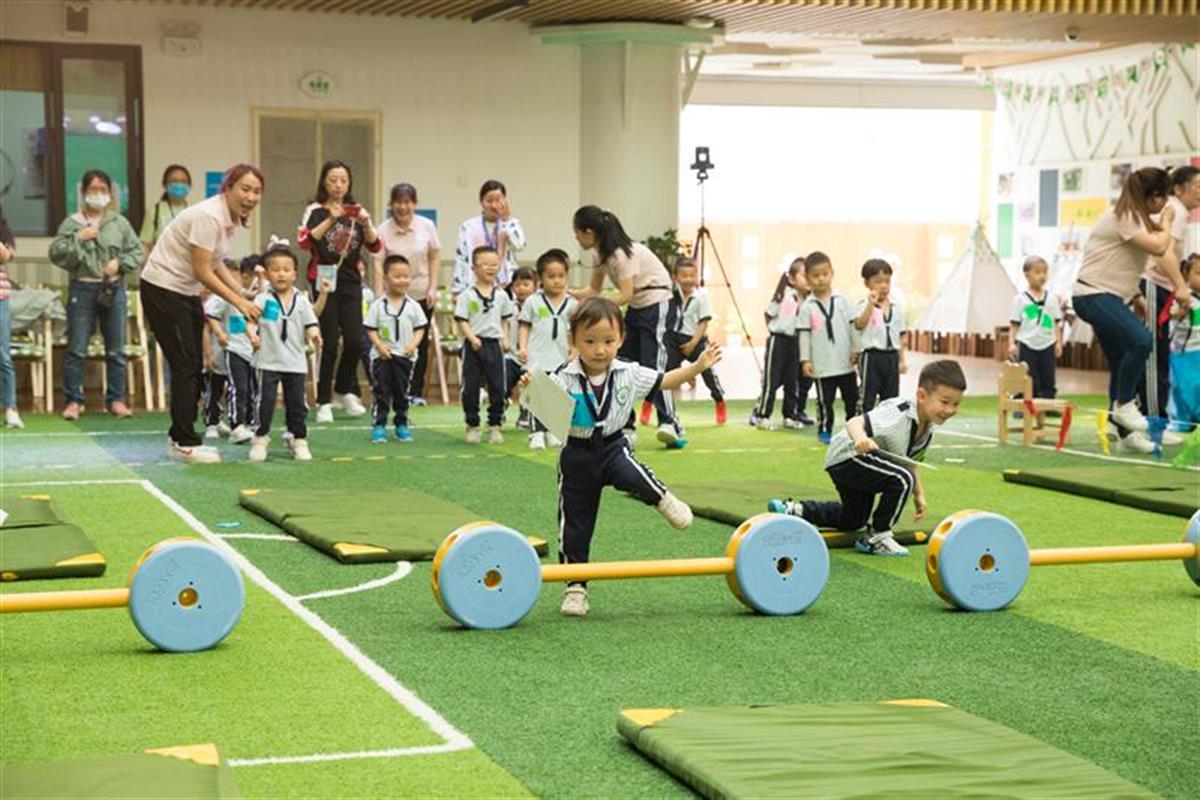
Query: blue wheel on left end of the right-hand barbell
926,511,1030,612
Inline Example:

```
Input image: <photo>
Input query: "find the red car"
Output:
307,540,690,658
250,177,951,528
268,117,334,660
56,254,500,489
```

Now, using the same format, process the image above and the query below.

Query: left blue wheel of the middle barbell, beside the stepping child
433,522,541,628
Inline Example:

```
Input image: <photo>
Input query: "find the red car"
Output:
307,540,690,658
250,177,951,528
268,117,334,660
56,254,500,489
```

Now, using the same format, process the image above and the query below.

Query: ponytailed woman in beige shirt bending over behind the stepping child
574,205,698,449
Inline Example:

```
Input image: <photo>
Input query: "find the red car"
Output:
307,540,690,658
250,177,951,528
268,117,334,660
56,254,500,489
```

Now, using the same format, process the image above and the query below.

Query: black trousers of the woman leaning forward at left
138,281,205,447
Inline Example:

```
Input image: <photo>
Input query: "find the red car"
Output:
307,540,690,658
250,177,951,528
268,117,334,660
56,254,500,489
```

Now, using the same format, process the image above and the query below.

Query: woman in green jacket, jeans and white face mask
50,169,144,420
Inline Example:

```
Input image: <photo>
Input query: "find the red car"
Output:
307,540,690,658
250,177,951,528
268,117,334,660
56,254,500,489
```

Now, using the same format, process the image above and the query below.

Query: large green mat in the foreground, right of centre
617,700,1158,800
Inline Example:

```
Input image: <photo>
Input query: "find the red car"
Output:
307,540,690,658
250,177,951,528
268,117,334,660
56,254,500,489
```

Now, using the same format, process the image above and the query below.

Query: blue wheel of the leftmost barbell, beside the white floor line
130,540,246,652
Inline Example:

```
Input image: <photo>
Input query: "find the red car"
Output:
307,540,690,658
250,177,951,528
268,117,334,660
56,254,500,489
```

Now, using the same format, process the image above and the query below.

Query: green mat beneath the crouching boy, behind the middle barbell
671,480,942,547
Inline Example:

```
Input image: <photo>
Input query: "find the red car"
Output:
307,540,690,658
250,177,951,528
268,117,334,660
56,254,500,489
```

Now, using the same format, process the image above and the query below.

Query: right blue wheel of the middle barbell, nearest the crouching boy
726,513,829,615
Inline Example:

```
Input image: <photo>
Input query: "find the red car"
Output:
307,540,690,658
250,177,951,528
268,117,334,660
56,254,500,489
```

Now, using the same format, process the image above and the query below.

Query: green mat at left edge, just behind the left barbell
0,494,108,581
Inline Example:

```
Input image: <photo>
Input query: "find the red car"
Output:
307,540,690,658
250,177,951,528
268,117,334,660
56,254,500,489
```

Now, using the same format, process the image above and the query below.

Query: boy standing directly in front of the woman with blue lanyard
454,245,514,445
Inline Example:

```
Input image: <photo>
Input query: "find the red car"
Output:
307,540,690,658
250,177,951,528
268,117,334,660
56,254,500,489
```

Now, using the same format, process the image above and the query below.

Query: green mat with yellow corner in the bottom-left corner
0,745,241,800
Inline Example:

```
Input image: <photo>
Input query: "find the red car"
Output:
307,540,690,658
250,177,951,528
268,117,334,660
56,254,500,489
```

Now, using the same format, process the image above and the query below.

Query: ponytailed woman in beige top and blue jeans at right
1072,167,1188,452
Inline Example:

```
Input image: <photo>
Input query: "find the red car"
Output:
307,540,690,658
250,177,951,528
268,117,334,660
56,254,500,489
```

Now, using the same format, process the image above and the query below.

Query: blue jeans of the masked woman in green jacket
62,281,126,405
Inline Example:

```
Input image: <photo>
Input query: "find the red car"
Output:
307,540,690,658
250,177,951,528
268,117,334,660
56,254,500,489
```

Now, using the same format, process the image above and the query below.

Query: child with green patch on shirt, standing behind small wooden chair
1008,255,1062,398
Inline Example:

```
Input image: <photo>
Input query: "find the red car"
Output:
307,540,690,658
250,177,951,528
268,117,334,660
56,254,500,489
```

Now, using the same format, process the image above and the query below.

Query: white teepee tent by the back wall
913,225,1016,335
